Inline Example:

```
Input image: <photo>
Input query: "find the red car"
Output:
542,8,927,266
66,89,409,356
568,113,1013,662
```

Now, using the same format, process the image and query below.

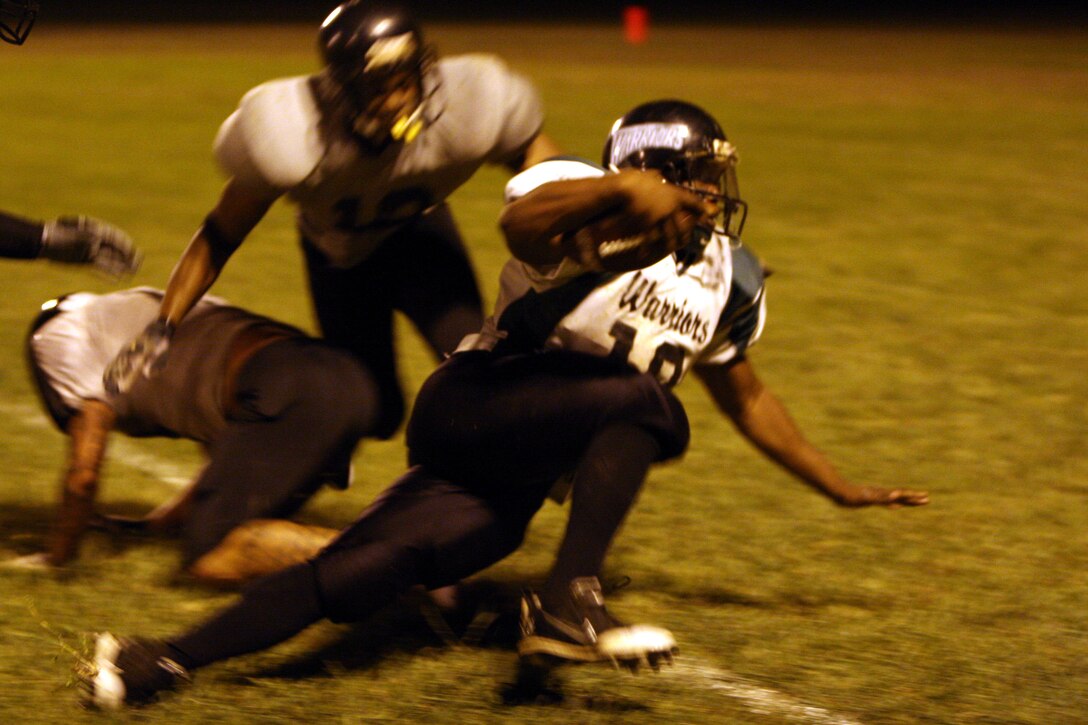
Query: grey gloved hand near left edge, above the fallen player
41,217,140,278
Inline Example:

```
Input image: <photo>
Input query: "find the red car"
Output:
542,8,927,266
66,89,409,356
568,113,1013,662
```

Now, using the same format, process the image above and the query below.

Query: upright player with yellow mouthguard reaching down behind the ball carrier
107,0,557,437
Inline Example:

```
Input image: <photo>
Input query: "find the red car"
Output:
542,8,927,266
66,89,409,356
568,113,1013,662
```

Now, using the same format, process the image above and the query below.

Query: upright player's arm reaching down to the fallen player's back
102,180,275,395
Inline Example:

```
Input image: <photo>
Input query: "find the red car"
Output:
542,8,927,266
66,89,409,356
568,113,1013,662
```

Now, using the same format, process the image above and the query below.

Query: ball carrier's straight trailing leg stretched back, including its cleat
92,467,544,706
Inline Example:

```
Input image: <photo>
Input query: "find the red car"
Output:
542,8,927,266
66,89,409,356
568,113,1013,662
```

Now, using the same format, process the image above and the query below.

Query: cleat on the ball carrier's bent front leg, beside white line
518,577,677,673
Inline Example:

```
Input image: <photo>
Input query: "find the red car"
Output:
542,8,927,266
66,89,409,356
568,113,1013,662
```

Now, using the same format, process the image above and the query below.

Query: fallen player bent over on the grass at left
10,287,376,583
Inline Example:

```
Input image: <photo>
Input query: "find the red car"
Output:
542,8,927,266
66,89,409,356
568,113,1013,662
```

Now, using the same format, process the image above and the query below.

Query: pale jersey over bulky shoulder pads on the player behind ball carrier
215,54,544,267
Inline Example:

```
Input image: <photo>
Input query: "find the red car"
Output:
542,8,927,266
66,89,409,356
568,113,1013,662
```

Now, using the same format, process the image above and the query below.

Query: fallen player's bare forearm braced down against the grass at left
48,401,115,566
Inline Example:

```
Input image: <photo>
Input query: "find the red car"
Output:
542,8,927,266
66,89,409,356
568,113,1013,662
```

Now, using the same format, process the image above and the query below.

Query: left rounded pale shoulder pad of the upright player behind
215,76,324,193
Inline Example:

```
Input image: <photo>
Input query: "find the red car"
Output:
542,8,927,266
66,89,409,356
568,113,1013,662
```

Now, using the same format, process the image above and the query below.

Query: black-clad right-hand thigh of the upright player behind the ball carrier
381,204,483,357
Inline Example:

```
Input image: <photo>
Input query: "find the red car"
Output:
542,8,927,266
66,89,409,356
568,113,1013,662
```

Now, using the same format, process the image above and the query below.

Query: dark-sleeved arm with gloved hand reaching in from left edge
0,211,140,277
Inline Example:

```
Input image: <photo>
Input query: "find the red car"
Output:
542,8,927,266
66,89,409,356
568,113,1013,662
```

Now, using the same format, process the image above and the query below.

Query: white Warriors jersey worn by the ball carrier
459,159,766,385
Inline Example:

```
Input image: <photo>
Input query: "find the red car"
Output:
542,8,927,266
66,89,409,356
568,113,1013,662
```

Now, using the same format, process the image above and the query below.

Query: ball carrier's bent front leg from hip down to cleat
408,353,689,663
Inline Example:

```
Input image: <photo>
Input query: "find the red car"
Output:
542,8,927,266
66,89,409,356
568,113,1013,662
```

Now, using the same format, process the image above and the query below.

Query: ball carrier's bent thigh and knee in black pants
407,351,688,491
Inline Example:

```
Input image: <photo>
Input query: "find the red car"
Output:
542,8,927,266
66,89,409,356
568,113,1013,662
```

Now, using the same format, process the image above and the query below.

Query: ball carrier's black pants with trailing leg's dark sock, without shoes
171,352,689,667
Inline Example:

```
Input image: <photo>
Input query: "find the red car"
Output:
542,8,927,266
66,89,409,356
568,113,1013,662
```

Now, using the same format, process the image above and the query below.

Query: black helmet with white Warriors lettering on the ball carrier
602,100,747,241
